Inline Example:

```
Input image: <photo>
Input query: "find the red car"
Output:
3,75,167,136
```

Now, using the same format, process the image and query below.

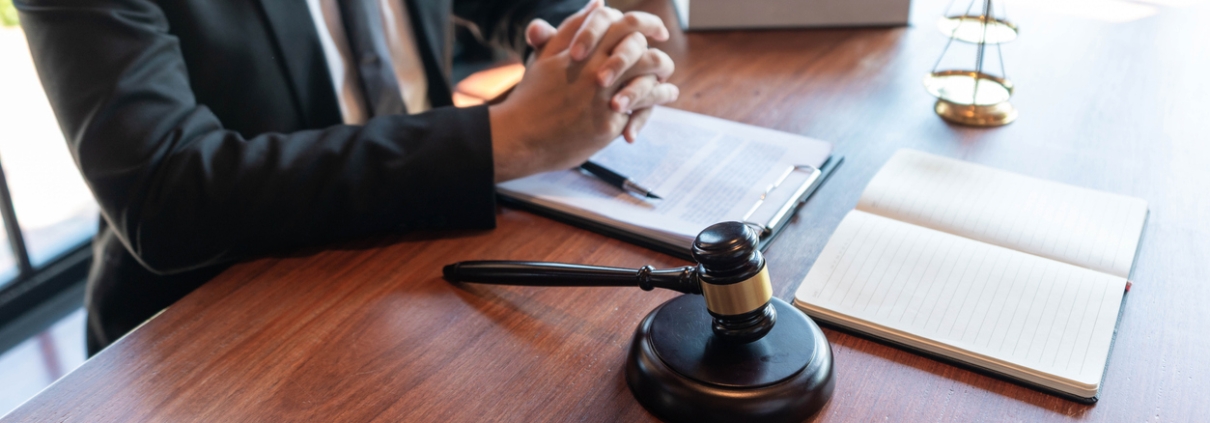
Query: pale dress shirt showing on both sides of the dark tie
306,0,430,124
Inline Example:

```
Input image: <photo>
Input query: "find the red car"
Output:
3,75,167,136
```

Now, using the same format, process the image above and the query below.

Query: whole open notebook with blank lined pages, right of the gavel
795,150,1147,401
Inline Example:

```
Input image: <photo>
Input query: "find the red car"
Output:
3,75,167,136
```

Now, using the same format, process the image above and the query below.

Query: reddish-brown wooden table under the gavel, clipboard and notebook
6,0,1210,422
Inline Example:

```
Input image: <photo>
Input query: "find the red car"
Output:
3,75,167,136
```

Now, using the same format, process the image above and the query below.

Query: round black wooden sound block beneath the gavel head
626,295,834,422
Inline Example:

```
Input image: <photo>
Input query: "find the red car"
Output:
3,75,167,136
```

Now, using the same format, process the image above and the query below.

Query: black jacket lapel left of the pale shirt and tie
260,0,342,128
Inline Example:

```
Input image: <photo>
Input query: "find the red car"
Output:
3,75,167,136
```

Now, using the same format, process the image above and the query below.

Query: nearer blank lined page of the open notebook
795,210,1125,398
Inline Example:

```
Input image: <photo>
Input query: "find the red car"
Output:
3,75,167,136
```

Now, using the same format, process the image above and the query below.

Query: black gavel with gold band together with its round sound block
443,222,834,422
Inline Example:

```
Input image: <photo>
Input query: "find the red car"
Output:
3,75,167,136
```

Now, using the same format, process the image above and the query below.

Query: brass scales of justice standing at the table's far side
924,0,1018,127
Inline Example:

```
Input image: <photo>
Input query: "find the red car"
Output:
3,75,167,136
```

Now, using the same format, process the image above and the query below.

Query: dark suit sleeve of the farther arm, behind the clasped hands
454,0,588,57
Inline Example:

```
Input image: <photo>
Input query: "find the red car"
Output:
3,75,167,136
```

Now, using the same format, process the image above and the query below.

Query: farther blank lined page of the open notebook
857,149,1147,278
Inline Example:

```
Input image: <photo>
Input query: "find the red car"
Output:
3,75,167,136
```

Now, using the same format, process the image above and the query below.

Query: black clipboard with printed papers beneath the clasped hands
497,106,839,259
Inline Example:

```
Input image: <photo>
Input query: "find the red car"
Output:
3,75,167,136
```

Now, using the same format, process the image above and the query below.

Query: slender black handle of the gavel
442,261,702,294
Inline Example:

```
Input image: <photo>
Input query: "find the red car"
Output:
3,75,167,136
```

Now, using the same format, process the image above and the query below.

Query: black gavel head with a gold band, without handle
693,221,777,343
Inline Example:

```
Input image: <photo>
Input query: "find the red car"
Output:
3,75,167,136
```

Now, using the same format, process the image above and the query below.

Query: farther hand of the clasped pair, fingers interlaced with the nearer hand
525,0,679,143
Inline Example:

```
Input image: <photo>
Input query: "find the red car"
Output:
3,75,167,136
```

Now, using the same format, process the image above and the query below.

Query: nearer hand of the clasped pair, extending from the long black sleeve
489,6,679,181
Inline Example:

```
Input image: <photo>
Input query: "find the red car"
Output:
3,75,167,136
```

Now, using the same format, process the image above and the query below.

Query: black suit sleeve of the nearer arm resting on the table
17,0,495,274
